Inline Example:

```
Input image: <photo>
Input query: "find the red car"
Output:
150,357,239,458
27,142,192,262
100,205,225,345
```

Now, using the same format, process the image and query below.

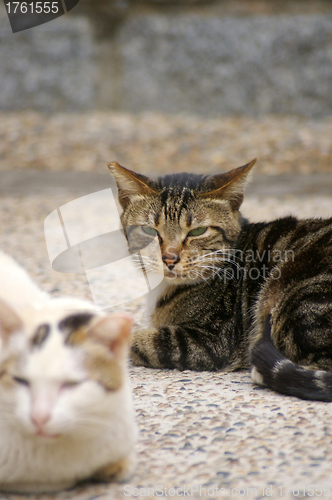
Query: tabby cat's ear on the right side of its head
200,158,256,210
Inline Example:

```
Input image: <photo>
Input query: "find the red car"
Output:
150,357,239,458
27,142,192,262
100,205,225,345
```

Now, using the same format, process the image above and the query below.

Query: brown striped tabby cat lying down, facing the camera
109,160,332,401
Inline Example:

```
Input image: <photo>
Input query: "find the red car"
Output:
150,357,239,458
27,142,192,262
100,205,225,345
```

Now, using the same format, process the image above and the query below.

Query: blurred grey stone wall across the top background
0,0,332,117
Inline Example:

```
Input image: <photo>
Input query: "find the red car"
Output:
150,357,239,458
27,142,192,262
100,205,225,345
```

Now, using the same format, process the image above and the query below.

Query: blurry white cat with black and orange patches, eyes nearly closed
0,252,137,493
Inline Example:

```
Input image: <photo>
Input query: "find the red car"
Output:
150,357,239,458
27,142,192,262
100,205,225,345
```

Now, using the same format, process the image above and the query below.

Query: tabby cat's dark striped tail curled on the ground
251,316,332,401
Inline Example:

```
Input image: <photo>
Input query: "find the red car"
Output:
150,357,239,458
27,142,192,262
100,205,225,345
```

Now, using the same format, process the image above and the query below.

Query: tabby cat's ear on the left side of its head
107,162,158,209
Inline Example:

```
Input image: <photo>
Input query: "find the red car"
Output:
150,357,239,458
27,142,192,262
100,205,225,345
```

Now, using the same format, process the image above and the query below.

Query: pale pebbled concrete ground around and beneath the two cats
0,171,332,500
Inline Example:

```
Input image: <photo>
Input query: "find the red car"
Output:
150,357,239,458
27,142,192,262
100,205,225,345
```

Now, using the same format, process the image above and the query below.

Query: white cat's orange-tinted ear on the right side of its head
88,313,133,356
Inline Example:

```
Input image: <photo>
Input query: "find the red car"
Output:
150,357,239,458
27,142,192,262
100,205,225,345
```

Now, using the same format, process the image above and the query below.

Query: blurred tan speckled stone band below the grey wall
0,111,332,175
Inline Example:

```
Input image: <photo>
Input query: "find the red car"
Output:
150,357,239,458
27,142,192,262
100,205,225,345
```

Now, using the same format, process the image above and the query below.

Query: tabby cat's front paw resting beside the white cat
130,328,161,368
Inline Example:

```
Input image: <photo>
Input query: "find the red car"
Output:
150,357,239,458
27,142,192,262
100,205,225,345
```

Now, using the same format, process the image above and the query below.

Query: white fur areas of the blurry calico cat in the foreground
0,252,137,492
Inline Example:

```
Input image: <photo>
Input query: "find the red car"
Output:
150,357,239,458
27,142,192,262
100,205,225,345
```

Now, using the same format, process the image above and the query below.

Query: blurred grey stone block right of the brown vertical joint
115,14,332,117
